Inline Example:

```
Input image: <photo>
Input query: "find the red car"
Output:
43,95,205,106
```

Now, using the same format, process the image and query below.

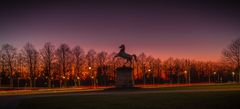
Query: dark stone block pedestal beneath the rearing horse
115,67,134,88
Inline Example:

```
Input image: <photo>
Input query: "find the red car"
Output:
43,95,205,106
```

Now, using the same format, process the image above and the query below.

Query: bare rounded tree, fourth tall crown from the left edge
56,44,72,86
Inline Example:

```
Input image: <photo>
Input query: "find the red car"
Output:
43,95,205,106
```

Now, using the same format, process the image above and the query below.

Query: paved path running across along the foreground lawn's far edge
0,88,240,109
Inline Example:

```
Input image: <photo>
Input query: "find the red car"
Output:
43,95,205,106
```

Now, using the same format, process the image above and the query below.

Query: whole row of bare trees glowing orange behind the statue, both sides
0,39,240,87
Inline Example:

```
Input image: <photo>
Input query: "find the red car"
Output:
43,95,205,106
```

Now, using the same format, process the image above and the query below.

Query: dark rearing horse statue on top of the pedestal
114,44,137,65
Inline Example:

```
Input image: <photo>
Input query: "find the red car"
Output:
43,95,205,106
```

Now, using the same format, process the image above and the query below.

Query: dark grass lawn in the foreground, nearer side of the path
18,92,240,109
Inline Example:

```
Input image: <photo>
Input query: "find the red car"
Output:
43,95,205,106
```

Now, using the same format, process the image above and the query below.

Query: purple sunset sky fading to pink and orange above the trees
0,0,240,61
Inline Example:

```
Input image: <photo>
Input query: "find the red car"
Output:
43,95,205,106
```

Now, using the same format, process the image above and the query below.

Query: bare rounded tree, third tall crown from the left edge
40,42,55,87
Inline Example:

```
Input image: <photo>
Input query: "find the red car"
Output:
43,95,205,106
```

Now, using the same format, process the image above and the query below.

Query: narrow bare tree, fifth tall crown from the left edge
72,46,85,86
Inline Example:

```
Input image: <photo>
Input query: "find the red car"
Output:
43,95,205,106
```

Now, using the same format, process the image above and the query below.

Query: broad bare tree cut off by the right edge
222,38,240,83
